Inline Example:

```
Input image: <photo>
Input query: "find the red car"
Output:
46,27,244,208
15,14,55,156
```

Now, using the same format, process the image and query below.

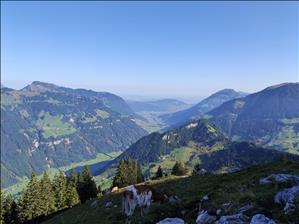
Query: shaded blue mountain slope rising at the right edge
208,83,299,153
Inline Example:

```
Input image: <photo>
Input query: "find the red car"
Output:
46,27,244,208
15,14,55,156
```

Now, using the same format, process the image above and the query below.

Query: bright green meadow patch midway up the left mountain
36,111,76,138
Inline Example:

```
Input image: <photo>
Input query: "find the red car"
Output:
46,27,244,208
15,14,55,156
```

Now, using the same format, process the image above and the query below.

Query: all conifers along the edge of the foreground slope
0,159,199,224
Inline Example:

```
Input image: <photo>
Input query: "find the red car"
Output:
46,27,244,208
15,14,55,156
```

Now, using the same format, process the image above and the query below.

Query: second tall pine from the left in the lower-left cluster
40,172,56,215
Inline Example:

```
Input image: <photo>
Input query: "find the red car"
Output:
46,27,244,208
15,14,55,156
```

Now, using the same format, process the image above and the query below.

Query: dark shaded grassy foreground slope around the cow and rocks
44,161,299,224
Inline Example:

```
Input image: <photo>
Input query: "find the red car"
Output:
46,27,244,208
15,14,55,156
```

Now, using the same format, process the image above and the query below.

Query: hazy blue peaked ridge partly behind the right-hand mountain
161,89,246,127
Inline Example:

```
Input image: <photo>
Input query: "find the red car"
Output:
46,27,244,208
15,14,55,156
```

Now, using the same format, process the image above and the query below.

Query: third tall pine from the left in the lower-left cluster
53,170,67,211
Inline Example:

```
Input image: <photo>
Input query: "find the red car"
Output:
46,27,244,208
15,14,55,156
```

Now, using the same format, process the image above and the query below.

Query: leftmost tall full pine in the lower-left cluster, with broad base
19,173,43,222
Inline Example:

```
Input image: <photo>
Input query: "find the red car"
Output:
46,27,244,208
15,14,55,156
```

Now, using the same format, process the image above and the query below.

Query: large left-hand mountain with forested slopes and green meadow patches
1,82,147,187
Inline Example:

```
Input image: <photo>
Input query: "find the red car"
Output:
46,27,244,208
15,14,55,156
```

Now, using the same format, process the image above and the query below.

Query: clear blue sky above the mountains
1,1,299,102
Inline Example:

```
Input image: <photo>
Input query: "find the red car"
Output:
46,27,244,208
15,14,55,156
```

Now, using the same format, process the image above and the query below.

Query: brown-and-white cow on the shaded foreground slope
122,185,168,223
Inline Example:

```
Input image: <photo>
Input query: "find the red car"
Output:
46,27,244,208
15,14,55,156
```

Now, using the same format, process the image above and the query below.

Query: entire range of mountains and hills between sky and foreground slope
1,82,299,190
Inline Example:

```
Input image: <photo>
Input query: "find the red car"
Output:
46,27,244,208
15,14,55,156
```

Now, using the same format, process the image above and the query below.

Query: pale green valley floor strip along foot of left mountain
3,151,121,195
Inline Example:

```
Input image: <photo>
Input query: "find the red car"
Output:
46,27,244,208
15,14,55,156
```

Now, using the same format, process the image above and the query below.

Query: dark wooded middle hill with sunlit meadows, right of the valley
98,119,299,184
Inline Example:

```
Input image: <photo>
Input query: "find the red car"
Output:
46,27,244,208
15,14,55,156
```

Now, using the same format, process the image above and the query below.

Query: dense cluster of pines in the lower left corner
1,166,98,224
